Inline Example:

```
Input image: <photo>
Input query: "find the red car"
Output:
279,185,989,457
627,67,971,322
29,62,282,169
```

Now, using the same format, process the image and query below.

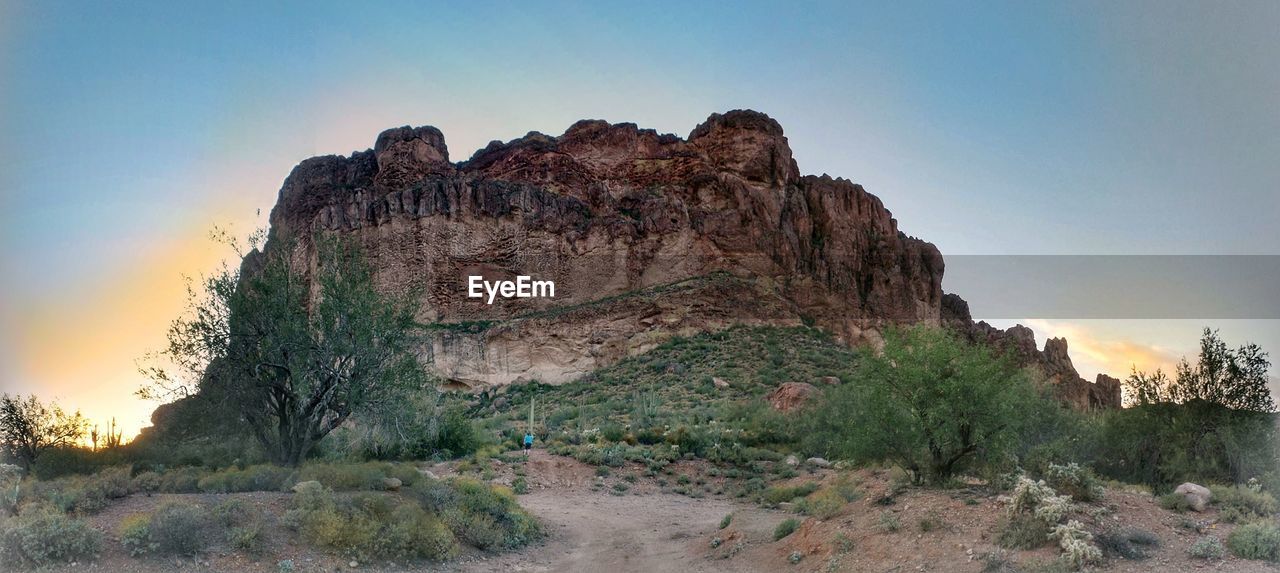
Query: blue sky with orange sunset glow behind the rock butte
0,0,1280,434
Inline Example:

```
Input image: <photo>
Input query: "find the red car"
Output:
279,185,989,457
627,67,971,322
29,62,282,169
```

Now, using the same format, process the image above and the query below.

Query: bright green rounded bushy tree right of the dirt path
806,325,1041,483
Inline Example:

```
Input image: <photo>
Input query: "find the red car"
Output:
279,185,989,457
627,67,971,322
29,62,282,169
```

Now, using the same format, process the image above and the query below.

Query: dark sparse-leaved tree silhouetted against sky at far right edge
1125,327,1276,412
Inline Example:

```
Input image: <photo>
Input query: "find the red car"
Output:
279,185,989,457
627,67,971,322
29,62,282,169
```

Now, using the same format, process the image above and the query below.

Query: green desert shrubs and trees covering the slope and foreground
0,235,1280,569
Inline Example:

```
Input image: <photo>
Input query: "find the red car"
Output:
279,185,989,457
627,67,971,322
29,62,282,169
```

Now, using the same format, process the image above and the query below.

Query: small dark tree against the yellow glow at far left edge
0,394,88,471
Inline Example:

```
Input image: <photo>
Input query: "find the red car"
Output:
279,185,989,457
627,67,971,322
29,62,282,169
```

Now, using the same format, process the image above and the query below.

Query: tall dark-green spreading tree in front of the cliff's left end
143,230,425,466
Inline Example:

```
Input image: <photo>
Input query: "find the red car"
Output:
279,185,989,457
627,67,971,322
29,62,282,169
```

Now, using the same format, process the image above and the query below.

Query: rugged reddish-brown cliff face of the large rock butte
271,111,1121,406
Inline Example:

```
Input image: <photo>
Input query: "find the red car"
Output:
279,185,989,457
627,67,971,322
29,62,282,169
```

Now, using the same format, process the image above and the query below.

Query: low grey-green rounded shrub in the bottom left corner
0,508,102,567
